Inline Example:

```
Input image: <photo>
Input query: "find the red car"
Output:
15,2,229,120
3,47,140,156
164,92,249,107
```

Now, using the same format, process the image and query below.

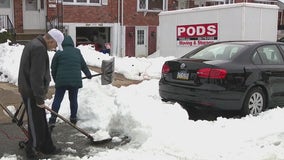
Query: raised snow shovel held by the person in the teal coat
82,58,114,85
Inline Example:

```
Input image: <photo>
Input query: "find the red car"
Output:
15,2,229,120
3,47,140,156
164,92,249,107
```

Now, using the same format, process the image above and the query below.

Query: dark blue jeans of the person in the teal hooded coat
49,87,78,123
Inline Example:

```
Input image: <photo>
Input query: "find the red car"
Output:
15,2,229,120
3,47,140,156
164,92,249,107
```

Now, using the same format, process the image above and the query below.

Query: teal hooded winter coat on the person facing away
51,36,91,88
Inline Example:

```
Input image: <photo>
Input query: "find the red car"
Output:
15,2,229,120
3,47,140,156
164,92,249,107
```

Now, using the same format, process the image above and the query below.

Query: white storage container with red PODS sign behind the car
158,3,279,57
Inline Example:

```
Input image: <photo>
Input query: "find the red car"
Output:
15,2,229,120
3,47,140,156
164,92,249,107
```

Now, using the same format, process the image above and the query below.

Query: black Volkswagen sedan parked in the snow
159,41,284,115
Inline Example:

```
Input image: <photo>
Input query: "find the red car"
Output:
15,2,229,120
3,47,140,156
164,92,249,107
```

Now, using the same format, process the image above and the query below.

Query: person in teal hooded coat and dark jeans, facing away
49,35,92,129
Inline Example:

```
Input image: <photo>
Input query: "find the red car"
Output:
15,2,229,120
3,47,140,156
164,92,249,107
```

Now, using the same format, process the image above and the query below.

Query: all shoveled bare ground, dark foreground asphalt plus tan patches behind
0,67,140,159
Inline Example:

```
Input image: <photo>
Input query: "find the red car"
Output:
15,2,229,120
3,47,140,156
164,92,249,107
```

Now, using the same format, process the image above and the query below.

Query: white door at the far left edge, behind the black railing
0,0,14,29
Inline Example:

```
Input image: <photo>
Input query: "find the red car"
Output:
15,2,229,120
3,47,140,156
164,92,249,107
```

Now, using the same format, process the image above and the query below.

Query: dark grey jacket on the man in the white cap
18,36,51,104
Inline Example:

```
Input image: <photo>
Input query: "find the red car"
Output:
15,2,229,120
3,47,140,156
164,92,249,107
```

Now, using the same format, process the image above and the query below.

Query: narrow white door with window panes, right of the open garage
135,26,148,57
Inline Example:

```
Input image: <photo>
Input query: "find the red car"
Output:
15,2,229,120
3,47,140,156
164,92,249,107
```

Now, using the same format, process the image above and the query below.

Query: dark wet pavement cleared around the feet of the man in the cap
0,120,131,160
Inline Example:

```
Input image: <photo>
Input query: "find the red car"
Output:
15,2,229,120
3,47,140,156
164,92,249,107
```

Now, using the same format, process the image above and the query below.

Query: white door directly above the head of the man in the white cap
23,0,46,30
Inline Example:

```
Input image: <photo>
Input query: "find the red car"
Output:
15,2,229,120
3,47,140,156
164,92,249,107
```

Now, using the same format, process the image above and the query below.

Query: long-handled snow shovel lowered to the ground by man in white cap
44,106,112,145
